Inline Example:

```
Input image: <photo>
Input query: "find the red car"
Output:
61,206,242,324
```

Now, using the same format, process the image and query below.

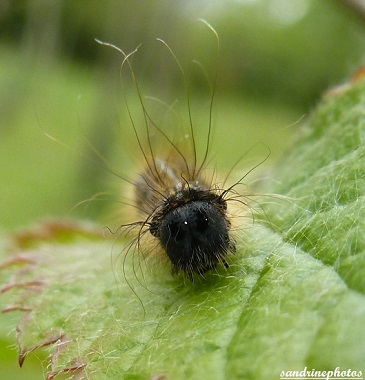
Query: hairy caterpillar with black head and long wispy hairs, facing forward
97,23,267,281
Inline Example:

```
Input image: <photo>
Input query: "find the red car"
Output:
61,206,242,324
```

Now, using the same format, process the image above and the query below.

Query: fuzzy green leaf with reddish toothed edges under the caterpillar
0,81,365,380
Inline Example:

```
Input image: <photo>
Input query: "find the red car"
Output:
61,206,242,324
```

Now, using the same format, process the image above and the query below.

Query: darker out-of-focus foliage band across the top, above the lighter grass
0,0,365,109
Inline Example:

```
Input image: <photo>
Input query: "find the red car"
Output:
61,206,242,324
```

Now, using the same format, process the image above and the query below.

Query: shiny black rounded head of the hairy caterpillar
150,188,234,279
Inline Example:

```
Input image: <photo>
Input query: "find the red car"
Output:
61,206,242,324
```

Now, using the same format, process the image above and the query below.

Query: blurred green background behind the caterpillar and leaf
0,0,365,379
